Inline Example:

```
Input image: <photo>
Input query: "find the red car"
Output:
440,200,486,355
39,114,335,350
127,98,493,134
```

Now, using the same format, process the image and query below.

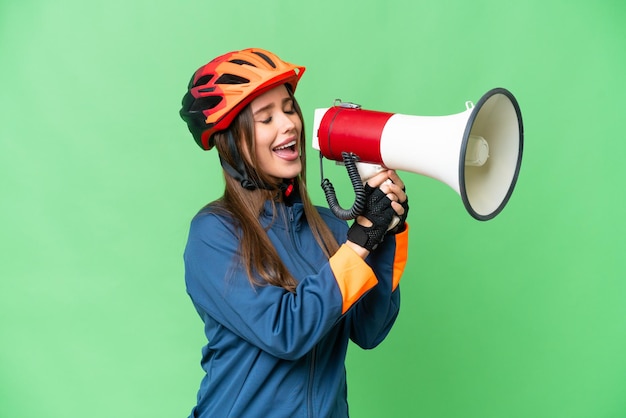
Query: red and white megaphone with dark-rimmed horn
313,88,524,221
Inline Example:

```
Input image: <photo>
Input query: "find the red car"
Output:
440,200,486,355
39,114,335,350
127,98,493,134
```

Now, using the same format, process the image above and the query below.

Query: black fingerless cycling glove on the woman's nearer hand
348,184,396,251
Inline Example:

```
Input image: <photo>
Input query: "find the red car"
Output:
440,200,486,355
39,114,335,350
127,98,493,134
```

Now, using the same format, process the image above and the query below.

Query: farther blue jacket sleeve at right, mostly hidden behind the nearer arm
350,226,408,349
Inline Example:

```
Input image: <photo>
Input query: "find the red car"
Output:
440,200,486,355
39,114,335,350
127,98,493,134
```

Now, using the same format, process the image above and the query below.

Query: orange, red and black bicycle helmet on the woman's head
180,48,305,150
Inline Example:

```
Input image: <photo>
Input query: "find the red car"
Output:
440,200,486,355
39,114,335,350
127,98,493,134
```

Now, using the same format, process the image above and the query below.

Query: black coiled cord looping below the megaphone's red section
320,152,366,221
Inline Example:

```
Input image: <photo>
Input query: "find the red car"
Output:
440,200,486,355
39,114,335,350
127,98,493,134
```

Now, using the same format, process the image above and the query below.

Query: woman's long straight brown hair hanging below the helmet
211,89,339,292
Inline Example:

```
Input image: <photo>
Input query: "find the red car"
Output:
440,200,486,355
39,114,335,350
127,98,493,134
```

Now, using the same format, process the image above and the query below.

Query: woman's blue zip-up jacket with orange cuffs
184,198,408,418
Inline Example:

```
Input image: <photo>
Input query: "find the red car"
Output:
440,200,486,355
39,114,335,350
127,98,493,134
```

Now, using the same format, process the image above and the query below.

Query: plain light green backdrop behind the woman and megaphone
0,0,626,418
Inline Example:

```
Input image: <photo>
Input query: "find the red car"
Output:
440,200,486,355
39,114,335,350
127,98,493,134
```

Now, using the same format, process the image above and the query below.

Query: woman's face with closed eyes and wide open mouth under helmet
250,85,302,183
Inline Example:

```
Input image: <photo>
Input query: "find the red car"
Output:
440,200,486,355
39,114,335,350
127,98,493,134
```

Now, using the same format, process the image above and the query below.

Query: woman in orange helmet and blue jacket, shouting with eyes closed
180,49,408,418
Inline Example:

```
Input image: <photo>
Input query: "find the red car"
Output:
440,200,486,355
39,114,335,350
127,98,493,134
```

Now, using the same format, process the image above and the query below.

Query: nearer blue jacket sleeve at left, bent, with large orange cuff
184,214,377,360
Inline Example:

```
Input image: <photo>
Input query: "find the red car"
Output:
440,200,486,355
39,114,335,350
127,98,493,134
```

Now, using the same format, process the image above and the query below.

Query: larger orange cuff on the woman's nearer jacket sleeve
329,244,378,313
